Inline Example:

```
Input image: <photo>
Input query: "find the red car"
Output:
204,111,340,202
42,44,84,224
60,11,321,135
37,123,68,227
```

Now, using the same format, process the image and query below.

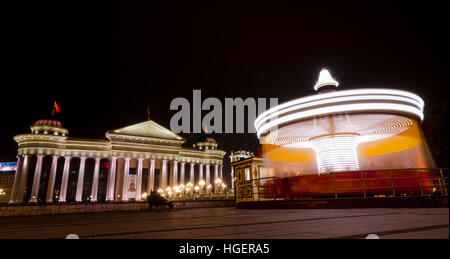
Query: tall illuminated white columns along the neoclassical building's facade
10,155,223,203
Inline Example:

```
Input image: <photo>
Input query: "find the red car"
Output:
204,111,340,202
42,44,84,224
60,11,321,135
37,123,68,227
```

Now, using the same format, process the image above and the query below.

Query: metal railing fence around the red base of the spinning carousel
236,168,449,202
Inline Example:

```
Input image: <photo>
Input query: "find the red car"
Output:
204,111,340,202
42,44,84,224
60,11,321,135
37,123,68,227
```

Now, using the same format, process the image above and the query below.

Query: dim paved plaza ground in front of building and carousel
0,207,449,239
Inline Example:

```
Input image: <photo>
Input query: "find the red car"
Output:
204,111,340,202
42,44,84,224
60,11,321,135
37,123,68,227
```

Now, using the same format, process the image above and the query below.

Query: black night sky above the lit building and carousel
0,1,449,167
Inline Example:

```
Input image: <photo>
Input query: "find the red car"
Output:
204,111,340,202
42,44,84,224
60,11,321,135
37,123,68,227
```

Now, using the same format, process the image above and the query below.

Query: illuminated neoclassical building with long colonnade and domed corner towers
10,120,226,203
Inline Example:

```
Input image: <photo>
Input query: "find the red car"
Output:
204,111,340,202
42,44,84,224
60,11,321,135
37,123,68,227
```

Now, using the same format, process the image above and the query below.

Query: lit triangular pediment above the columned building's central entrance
106,120,186,142
